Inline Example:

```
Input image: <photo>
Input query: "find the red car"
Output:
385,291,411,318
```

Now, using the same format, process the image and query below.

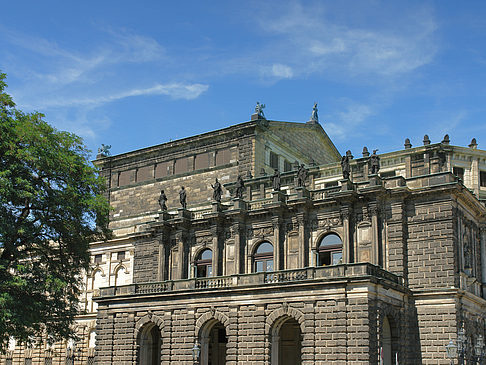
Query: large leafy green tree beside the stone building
0,73,109,351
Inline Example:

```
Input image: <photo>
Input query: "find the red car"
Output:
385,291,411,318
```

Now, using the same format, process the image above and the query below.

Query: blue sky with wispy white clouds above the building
0,0,486,156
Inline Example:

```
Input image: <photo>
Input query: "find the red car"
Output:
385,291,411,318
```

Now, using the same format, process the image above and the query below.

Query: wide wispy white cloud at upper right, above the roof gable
252,2,438,77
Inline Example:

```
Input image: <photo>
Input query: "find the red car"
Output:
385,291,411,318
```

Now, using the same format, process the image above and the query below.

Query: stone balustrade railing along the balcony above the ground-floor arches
97,263,403,297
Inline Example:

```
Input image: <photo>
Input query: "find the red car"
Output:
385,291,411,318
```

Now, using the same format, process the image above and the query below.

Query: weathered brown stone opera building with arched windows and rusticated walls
2,119,486,365
